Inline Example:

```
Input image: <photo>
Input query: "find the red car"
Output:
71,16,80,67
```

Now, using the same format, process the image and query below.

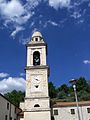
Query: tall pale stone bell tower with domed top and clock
23,32,51,120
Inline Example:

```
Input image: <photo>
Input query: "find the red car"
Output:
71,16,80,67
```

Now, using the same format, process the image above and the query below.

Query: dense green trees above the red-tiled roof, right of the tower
49,77,90,101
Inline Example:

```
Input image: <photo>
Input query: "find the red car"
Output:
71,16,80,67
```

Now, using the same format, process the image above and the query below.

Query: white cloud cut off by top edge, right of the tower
49,0,71,9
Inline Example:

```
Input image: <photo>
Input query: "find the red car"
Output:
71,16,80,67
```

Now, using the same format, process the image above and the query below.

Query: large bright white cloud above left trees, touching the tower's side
0,77,26,94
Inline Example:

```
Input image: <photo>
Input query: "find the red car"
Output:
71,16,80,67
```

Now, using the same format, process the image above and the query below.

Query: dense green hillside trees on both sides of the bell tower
4,77,90,106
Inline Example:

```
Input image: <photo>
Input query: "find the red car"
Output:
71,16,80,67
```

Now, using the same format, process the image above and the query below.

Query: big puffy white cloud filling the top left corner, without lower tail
0,0,38,25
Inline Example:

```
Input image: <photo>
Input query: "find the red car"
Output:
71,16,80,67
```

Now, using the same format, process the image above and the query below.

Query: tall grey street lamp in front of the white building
69,79,81,120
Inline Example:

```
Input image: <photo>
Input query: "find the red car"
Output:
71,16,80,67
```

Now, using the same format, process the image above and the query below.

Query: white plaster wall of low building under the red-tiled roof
53,106,90,120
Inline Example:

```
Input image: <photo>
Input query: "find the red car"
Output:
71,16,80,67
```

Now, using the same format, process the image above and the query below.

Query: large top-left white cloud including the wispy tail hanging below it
0,0,33,36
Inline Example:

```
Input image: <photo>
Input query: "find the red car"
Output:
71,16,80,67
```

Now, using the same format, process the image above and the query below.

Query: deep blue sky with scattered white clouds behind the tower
0,0,90,94
